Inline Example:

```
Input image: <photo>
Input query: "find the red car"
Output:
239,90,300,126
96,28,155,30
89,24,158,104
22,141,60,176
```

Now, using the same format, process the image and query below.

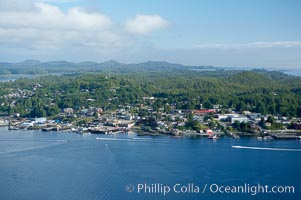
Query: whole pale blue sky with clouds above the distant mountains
0,0,301,69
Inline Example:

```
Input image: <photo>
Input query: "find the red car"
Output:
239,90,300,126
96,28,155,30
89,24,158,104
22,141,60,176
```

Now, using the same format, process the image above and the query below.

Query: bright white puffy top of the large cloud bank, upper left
0,3,112,30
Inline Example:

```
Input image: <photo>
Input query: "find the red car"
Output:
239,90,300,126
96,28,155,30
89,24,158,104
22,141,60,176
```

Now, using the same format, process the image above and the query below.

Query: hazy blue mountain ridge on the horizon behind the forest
0,60,215,74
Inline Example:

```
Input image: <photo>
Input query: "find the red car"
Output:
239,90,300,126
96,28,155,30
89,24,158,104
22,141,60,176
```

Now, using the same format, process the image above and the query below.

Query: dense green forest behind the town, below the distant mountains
0,67,301,118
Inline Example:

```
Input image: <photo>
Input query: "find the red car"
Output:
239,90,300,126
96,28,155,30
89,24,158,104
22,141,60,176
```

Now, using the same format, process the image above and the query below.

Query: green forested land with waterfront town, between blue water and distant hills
0,69,301,139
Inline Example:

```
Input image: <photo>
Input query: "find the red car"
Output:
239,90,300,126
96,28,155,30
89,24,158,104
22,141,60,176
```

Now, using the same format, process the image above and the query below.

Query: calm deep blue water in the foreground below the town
0,128,301,200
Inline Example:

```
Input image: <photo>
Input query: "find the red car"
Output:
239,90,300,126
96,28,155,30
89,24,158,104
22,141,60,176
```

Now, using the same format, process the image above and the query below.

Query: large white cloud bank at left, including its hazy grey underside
0,0,129,49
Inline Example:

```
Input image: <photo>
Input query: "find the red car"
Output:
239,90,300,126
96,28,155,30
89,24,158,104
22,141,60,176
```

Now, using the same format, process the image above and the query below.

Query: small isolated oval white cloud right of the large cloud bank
125,14,168,35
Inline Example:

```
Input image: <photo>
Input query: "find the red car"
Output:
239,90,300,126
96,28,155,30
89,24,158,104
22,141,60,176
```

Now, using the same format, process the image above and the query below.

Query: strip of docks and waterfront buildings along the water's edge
0,115,301,140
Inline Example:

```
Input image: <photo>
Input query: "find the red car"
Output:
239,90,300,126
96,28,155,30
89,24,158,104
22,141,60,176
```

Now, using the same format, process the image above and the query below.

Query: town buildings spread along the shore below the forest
0,84,301,140
